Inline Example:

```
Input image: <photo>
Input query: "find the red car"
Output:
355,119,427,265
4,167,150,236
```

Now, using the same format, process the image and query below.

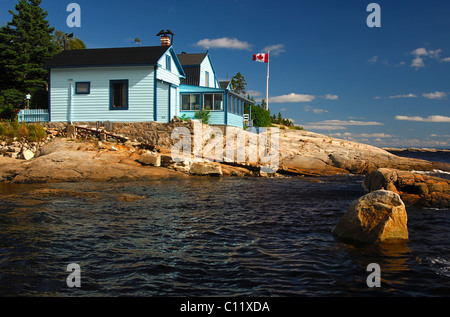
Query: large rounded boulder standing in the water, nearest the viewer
332,190,409,243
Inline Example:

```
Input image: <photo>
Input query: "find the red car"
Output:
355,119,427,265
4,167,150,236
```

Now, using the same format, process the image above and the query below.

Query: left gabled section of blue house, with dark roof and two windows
44,46,185,122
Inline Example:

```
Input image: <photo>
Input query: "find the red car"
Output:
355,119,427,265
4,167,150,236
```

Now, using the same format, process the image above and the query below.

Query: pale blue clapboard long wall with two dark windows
50,66,155,122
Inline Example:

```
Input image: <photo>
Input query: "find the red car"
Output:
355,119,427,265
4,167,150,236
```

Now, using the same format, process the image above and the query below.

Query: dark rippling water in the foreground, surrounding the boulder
0,176,450,297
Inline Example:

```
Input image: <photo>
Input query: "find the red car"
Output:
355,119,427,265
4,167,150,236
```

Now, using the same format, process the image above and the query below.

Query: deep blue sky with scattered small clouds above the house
0,0,450,148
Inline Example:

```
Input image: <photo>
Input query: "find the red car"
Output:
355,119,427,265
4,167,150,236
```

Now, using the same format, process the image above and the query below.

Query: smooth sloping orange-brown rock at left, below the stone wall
0,139,185,183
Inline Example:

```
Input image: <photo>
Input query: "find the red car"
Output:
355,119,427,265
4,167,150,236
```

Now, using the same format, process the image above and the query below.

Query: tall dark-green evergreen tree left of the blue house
0,0,58,107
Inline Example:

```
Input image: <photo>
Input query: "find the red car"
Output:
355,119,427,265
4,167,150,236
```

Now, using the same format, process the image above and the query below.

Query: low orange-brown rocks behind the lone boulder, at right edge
363,168,450,209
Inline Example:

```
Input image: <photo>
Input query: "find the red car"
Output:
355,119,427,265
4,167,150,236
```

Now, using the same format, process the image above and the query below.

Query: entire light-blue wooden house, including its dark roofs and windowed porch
44,45,249,128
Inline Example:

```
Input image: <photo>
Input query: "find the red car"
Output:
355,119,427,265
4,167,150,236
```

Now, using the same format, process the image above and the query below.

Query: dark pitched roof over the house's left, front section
44,46,169,68
